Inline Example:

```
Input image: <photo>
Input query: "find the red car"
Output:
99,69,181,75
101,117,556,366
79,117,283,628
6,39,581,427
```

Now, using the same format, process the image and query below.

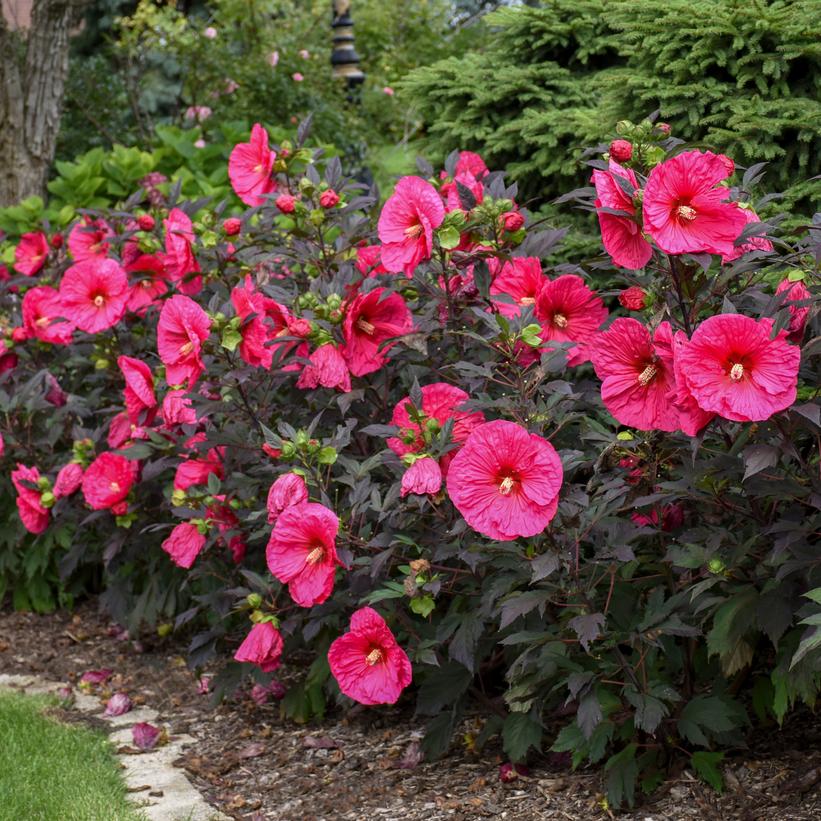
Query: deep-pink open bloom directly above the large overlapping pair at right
536,274,608,366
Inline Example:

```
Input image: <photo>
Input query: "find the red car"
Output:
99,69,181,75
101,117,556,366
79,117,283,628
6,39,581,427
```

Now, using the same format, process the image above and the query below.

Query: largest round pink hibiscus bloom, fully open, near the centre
447,419,563,541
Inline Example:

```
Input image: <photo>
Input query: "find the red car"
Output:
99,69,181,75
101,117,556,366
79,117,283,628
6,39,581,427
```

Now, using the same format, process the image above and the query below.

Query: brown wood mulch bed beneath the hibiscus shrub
0,603,821,821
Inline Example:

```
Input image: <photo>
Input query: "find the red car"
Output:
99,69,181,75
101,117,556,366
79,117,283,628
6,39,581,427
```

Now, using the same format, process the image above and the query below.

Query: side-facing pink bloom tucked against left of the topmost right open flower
593,160,653,271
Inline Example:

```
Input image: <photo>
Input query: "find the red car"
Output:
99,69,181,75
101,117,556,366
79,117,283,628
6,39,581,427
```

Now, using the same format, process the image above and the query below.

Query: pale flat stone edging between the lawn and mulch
0,673,230,821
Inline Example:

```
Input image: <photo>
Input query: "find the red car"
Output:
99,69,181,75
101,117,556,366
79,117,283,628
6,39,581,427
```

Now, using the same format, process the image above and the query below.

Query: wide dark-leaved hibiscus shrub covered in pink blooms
0,120,821,806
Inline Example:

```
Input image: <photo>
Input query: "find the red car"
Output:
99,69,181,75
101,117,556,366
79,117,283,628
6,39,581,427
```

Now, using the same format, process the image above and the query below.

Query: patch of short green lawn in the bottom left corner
0,692,144,821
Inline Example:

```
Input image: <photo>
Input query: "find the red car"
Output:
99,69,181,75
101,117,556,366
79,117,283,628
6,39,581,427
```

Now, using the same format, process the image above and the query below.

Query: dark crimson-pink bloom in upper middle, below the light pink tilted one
342,288,413,376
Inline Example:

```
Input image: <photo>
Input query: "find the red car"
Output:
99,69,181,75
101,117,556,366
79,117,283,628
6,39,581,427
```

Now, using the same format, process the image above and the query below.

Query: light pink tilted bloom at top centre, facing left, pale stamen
378,177,445,276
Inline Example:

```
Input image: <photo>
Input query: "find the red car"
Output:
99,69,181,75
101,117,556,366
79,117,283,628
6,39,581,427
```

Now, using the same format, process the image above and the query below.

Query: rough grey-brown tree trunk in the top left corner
0,0,87,206
